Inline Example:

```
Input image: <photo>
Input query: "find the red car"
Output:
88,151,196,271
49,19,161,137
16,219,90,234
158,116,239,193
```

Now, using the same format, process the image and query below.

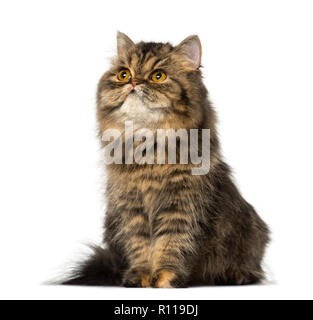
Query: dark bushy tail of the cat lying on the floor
58,246,122,286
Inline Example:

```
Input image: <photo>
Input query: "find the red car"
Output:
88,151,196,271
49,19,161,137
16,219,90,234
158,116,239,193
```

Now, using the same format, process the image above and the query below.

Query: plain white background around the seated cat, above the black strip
0,0,313,299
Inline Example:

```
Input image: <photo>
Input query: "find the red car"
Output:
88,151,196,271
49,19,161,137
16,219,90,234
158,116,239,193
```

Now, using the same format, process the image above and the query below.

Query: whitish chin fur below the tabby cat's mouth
118,93,165,127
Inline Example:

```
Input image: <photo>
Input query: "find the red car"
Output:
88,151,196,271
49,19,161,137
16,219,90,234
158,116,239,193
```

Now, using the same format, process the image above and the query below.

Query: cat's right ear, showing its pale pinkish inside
174,35,202,69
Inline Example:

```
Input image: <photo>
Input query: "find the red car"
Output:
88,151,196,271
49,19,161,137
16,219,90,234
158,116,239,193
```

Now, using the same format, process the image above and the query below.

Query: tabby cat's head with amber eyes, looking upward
98,32,206,131
